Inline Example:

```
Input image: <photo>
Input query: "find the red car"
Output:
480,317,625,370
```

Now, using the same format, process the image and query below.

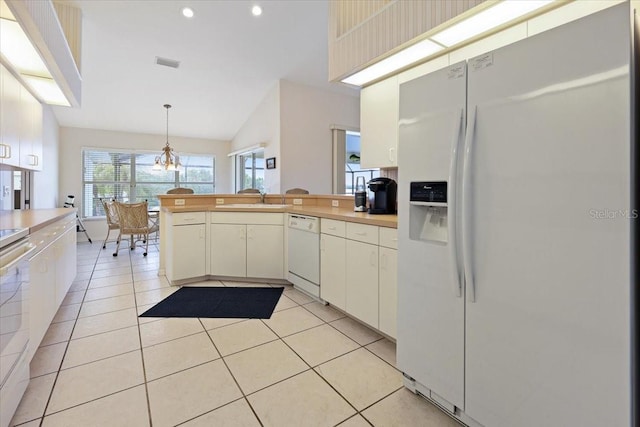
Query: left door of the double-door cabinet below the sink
212,224,247,277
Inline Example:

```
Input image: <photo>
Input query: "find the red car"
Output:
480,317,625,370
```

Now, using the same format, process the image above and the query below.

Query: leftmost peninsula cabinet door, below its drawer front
169,224,206,281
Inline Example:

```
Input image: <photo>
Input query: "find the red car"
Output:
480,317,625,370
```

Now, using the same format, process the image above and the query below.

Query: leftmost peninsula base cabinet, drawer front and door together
166,212,207,282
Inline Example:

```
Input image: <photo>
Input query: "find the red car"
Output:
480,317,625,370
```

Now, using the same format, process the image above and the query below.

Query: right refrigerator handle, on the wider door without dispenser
462,106,477,303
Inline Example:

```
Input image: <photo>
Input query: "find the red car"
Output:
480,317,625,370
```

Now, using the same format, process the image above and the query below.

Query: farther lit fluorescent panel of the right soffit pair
342,40,444,86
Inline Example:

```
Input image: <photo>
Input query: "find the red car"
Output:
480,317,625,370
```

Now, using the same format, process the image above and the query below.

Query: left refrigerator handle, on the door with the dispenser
447,109,463,297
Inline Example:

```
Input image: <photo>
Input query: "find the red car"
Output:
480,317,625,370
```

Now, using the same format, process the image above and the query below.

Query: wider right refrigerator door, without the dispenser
464,4,633,427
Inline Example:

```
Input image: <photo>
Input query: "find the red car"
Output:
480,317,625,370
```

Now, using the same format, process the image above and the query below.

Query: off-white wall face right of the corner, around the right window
278,80,360,194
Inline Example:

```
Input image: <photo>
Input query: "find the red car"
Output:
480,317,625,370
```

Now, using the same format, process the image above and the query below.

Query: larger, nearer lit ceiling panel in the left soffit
0,19,51,77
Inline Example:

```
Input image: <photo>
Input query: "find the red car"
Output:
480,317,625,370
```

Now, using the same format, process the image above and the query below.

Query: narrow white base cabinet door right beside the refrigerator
378,247,398,338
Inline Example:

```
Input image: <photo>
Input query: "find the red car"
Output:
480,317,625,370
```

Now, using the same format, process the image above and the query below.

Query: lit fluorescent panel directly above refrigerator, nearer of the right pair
430,0,552,47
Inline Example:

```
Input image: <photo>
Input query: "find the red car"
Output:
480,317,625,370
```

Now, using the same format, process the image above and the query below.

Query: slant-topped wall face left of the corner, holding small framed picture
228,83,281,193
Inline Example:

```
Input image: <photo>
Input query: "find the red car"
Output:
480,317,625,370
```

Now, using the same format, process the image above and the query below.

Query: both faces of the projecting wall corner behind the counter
231,80,360,194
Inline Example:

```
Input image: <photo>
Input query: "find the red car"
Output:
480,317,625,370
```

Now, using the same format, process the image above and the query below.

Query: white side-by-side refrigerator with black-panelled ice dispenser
397,3,637,427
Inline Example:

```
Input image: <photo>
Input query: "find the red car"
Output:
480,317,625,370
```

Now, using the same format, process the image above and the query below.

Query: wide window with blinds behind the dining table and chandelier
82,150,215,218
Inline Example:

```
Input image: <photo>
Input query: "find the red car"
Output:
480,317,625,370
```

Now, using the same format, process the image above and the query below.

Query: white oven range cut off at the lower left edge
0,229,35,427
